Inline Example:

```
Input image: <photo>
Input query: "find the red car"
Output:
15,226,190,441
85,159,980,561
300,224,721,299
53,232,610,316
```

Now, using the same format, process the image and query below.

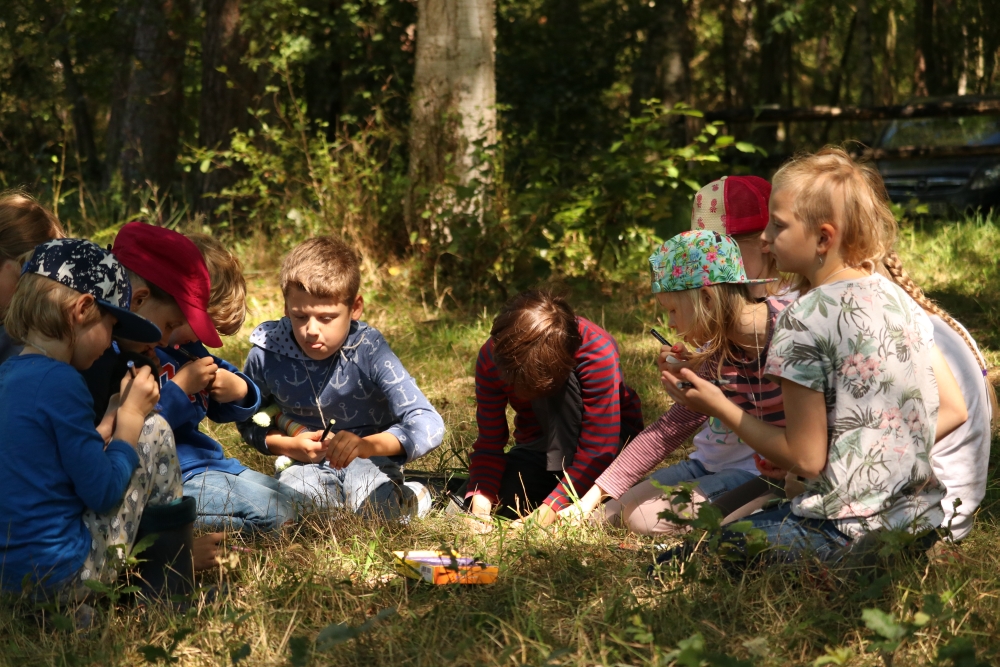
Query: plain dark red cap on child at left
111,222,222,347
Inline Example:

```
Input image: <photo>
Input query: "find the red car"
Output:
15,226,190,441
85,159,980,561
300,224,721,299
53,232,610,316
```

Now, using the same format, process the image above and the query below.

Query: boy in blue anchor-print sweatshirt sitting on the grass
239,237,444,518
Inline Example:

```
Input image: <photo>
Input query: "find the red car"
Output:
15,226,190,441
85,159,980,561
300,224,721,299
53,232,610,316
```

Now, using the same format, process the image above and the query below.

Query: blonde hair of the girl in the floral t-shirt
771,146,897,287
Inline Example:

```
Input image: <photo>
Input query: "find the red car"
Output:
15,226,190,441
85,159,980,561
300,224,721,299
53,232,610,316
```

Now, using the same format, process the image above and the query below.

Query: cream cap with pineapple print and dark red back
691,176,771,236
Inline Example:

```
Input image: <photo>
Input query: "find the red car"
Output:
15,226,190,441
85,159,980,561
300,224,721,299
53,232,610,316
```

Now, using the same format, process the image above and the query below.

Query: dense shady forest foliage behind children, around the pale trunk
0,0,1000,296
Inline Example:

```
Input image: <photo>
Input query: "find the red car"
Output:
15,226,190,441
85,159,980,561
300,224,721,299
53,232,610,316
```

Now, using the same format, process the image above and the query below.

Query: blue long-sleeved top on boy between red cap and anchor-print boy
156,343,260,482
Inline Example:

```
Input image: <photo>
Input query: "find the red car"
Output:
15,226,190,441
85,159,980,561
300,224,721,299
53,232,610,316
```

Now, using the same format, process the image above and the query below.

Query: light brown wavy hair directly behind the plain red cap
186,233,247,336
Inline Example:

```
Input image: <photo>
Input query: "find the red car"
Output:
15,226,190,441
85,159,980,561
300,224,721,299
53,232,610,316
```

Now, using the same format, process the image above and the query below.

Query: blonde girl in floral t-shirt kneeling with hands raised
663,149,966,558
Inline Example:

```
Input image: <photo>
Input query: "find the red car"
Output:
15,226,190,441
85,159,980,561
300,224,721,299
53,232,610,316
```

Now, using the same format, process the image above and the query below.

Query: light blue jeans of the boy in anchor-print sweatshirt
277,457,409,519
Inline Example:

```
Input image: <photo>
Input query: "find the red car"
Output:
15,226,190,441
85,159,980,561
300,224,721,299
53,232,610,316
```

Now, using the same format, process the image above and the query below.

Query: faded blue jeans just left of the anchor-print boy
184,469,308,533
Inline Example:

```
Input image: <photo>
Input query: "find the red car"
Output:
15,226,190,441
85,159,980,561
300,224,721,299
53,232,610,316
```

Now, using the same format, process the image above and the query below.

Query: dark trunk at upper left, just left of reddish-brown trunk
121,0,190,196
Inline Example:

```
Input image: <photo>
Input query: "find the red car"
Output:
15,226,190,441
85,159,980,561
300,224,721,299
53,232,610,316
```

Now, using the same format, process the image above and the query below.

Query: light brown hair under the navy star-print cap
4,273,101,343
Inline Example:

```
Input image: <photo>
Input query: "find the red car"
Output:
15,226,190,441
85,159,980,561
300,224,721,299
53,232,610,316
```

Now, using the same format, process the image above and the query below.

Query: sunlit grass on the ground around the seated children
0,220,1000,667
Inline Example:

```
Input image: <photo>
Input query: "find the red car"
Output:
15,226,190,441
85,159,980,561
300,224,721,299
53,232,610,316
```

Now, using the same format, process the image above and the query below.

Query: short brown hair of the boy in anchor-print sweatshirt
281,236,361,303
